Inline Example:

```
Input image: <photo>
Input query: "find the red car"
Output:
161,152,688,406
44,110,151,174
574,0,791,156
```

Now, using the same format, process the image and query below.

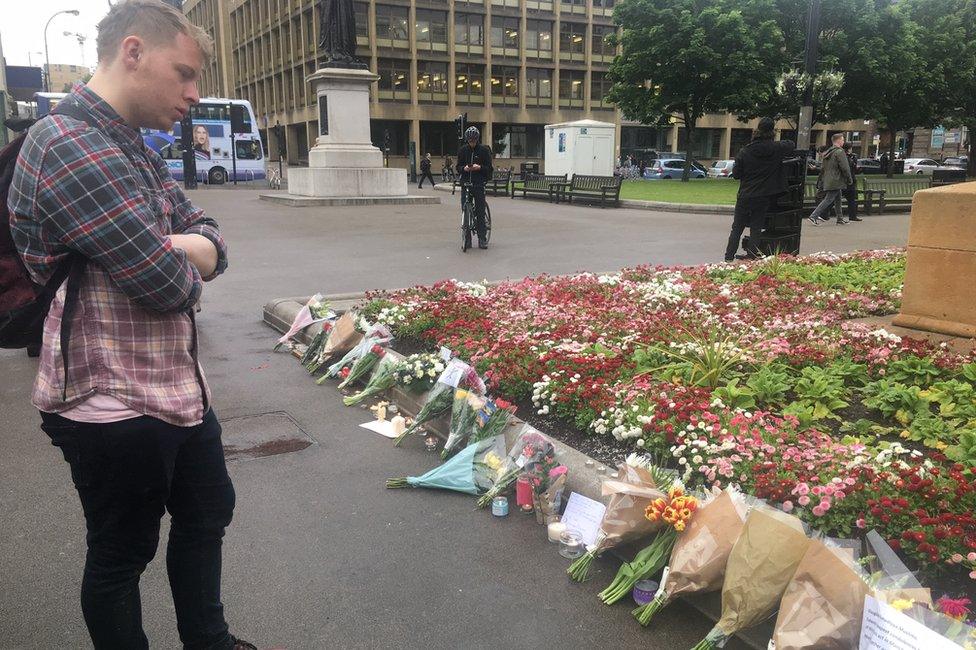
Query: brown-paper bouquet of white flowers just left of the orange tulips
566,462,672,582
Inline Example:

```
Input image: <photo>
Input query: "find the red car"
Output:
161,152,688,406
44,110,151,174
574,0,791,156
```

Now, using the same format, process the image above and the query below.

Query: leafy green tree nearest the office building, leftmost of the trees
608,0,784,181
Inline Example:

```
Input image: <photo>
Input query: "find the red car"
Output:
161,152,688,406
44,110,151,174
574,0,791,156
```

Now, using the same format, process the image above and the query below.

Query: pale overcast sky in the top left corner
0,0,117,67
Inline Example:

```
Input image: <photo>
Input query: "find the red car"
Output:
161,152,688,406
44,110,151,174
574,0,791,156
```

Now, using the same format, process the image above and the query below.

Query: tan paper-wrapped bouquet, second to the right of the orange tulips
693,505,810,650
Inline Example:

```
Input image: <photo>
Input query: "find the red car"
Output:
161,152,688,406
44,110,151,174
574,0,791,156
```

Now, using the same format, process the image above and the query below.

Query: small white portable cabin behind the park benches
545,120,615,177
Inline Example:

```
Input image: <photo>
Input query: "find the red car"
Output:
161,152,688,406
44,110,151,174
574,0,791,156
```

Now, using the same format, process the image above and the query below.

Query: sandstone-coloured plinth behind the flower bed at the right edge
894,183,976,338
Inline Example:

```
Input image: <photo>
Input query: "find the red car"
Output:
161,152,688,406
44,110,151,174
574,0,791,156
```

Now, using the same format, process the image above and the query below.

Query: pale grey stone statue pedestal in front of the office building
288,67,407,198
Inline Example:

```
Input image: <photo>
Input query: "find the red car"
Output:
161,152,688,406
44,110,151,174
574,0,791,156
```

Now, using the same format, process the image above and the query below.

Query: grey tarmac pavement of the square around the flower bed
0,188,909,649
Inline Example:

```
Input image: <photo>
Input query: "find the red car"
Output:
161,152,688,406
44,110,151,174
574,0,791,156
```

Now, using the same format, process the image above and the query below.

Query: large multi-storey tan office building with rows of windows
183,0,863,171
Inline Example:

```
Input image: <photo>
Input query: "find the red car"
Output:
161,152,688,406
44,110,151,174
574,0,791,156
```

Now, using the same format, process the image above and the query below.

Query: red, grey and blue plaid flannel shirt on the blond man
8,86,227,426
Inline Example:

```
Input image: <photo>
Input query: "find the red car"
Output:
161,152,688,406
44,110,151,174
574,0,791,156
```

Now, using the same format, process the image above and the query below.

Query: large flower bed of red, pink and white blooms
363,250,976,589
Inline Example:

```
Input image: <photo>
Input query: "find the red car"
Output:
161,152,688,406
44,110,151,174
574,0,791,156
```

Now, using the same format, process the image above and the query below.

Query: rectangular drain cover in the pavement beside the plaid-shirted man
220,411,315,460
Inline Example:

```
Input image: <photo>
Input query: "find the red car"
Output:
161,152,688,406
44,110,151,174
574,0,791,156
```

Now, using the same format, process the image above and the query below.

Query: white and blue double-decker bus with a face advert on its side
142,97,266,185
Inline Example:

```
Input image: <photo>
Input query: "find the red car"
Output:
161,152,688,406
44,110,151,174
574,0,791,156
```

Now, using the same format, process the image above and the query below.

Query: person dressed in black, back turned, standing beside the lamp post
725,117,796,262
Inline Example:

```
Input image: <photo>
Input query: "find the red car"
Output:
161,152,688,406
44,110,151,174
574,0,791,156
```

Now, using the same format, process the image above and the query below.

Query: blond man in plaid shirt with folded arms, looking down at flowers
8,0,264,650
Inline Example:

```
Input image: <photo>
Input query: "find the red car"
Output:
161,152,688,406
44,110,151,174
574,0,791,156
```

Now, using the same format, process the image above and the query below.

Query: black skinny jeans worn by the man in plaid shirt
41,411,234,650
